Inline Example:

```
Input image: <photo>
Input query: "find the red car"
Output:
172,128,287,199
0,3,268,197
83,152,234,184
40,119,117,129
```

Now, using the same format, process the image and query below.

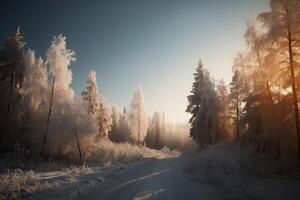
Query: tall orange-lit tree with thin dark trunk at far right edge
258,0,300,163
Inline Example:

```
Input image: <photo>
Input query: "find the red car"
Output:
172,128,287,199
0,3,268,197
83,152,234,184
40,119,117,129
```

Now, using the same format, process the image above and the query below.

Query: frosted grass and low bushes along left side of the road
0,140,180,200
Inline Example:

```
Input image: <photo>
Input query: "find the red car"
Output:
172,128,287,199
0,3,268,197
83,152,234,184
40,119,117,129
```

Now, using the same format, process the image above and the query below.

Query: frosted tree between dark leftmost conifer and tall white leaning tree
20,49,49,152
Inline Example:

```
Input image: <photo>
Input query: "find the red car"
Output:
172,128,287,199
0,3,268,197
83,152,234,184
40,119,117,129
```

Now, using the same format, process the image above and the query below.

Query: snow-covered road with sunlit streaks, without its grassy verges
82,157,212,200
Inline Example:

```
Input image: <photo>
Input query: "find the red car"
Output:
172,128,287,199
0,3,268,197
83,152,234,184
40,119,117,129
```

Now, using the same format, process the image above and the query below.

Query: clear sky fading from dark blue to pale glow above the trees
0,0,268,122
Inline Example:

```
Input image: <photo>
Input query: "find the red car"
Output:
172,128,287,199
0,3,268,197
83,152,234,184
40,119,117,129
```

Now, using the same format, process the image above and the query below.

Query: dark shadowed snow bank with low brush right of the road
184,144,300,200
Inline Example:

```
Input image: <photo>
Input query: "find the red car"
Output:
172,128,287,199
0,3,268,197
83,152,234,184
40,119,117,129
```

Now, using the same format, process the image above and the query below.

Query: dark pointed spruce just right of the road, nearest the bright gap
186,61,219,147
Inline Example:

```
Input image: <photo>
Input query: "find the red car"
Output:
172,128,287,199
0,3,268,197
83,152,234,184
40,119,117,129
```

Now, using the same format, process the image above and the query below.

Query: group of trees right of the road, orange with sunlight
187,0,300,163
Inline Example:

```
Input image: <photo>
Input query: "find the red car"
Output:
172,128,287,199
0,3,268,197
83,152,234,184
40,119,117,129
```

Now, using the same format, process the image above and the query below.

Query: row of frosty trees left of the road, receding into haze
0,28,192,162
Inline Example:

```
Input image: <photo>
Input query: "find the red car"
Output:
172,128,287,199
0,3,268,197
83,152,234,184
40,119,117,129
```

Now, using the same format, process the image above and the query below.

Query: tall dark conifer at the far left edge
0,27,25,151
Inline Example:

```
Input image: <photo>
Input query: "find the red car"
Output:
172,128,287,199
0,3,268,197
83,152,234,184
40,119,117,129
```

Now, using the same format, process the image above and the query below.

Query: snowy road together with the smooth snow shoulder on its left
29,156,210,200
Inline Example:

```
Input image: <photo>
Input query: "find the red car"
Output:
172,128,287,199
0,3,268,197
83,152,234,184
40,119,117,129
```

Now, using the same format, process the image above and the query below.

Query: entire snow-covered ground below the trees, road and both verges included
0,145,300,200
